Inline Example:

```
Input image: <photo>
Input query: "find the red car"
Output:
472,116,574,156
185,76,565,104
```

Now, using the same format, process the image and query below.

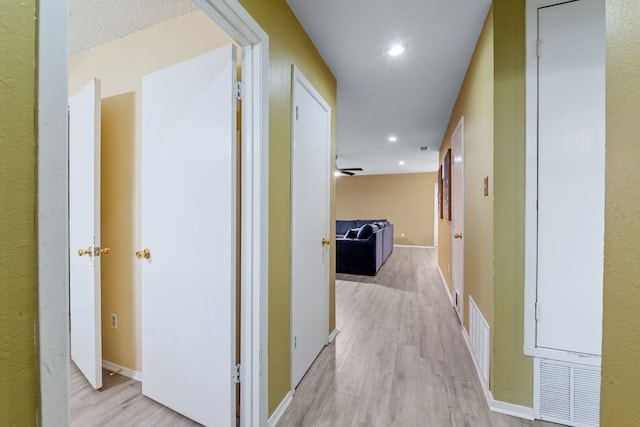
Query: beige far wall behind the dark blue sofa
336,172,438,246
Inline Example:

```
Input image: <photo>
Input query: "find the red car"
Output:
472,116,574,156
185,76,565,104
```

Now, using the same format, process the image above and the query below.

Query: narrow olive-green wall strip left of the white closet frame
491,0,533,407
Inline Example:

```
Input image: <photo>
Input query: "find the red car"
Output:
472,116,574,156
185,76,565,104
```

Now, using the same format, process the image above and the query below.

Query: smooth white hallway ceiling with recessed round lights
287,0,491,174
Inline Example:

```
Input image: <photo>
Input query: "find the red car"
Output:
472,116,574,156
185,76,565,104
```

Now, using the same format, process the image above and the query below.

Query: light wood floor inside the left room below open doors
69,363,200,427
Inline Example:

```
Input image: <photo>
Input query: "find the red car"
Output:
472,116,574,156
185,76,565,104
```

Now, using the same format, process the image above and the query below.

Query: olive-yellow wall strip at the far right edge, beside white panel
600,0,640,427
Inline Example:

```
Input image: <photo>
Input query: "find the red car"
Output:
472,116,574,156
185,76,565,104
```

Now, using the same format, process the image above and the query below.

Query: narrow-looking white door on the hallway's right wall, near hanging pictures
451,117,464,324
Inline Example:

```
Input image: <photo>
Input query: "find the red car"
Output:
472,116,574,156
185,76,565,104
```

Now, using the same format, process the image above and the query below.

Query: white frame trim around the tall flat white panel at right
523,0,601,366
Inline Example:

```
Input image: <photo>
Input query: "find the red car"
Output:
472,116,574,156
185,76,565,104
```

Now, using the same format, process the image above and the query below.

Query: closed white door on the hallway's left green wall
291,67,331,389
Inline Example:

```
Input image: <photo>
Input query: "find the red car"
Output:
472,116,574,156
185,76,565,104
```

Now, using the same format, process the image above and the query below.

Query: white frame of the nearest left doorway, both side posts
37,0,269,427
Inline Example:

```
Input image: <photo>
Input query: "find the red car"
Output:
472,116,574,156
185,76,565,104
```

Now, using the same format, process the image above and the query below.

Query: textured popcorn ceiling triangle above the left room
69,0,198,55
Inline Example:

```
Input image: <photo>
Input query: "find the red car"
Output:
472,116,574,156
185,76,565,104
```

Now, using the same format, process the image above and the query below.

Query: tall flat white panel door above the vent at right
537,0,605,355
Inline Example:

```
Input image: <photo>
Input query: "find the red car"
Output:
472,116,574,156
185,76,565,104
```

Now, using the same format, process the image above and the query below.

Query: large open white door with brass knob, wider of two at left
137,46,237,426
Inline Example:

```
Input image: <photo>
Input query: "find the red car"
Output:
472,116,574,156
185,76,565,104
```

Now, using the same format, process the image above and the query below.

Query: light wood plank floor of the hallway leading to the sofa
278,247,556,427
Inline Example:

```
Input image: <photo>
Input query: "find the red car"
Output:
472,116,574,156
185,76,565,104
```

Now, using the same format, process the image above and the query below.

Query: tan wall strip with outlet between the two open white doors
100,92,140,370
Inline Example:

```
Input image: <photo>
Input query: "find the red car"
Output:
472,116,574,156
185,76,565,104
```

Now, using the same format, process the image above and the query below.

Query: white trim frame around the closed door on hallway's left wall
289,65,331,396
